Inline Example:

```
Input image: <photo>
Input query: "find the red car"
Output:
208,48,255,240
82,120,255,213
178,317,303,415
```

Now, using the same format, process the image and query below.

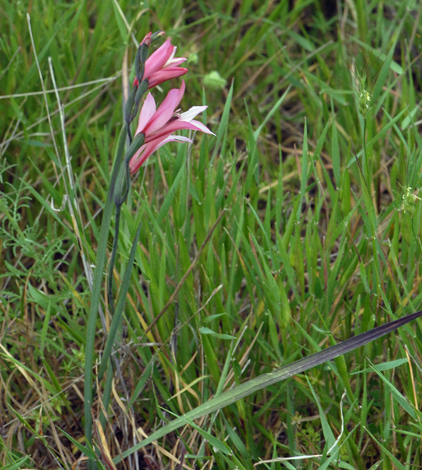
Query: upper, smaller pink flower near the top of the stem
133,33,188,88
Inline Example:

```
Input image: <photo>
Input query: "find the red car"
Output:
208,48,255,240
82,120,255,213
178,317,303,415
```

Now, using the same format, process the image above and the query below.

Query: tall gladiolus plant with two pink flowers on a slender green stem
84,32,212,458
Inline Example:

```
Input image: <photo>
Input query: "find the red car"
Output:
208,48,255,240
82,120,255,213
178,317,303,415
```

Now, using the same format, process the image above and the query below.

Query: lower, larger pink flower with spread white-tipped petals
129,81,215,174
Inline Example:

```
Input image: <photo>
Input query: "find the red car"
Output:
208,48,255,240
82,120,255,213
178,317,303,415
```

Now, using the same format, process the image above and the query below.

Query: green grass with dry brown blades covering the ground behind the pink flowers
0,0,422,470
